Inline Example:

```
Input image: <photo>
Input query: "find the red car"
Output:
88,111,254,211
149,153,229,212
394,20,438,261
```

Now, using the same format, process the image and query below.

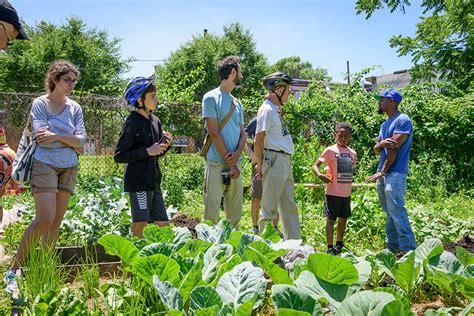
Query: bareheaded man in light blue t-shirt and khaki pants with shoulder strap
202,56,246,227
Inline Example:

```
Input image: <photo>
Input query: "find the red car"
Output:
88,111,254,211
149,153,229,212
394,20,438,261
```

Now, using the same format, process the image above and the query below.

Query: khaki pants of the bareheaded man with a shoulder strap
203,160,243,228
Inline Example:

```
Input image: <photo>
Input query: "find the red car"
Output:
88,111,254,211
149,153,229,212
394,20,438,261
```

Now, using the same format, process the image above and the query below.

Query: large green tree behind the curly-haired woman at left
0,17,130,95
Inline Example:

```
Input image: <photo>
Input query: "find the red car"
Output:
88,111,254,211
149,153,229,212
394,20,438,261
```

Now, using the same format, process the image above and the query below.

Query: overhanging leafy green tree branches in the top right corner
356,0,474,90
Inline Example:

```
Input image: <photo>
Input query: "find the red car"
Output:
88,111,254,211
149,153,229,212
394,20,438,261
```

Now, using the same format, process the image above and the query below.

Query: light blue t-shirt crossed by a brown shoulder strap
202,87,244,163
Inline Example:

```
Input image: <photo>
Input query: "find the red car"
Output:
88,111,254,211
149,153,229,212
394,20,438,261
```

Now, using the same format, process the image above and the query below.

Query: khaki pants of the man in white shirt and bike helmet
260,150,301,239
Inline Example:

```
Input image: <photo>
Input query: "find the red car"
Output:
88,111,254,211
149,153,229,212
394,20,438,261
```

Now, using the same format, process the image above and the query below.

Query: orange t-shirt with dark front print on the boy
318,144,357,197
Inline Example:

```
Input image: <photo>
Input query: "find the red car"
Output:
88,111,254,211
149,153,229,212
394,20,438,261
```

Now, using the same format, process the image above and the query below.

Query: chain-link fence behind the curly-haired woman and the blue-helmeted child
0,92,200,177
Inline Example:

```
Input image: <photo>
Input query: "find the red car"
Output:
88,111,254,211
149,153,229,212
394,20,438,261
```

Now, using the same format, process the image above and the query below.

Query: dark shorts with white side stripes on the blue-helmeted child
129,190,169,223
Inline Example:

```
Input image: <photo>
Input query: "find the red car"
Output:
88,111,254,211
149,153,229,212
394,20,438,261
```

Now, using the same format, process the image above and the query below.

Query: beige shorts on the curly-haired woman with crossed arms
31,159,77,194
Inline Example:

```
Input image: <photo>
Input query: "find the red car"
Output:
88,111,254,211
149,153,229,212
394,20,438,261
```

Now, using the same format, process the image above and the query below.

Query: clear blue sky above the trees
10,0,422,81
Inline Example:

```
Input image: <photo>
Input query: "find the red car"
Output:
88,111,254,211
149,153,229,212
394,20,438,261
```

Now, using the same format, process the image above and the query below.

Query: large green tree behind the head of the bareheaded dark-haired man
156,23,268,107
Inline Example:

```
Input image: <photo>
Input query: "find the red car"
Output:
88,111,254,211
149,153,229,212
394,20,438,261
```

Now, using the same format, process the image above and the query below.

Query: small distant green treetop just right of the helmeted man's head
271,56,331,82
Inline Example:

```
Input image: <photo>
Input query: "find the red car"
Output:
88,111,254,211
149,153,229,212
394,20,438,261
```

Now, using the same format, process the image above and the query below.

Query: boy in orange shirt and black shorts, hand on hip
312,122,357,256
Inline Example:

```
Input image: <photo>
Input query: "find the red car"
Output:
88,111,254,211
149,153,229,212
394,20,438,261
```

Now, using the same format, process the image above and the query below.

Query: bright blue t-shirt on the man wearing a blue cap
377,113,413,174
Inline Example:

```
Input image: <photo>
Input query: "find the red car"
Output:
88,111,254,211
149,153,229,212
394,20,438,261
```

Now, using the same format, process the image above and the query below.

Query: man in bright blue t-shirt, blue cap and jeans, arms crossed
367,89,416,255
